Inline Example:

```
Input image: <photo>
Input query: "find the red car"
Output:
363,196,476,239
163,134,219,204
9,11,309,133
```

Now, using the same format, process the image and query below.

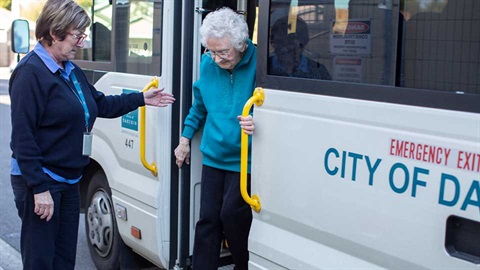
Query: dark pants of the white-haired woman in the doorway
193,165,252,270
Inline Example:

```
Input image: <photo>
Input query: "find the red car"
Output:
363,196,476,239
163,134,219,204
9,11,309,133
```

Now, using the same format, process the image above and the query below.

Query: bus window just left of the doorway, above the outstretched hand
115,1,162,75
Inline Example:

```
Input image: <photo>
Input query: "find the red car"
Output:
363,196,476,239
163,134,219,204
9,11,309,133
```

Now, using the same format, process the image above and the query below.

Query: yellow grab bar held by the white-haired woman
240,87,265,213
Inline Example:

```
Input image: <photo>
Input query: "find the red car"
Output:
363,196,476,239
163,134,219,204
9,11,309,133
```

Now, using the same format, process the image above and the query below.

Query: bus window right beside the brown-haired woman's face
75,0,112,62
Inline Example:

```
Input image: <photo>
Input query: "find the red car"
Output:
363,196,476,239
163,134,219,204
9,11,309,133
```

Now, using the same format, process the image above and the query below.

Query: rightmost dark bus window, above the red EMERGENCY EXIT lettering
400,0,480,94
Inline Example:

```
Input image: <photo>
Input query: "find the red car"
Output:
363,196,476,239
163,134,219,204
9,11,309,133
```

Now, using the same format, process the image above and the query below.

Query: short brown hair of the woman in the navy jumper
35,0,91,45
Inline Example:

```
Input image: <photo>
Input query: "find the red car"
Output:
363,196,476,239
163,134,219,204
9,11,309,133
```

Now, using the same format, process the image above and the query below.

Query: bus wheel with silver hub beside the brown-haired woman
85,171,124,269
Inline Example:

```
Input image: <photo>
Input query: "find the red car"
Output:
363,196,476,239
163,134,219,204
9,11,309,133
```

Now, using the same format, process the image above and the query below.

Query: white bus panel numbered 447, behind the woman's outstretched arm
92,73,171,266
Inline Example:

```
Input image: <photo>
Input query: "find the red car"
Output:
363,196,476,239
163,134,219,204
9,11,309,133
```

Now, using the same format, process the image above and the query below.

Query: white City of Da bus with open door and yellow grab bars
11,0,480,270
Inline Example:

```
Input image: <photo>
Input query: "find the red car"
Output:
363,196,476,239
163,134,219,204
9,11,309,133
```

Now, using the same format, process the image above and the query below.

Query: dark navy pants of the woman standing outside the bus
11,175,80,270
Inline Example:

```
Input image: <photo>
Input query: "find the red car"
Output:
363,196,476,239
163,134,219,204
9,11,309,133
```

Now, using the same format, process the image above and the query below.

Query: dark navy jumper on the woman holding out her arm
9,51,145,194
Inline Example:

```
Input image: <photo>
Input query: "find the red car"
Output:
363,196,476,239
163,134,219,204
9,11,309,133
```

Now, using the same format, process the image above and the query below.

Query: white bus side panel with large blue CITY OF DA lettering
249,89,480,269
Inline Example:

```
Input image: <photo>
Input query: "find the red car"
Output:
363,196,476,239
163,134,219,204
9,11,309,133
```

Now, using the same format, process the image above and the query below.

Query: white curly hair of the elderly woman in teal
200,7,248,51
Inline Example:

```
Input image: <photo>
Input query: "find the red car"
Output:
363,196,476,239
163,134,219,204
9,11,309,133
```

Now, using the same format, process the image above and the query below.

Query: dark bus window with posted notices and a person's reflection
268,0,398,85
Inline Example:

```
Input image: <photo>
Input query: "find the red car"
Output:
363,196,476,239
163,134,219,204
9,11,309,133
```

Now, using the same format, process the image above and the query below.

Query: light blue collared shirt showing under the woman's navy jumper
10,42,82,184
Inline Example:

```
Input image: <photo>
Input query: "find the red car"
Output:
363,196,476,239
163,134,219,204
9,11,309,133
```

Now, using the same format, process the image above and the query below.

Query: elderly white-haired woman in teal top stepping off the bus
175,8,257,270
